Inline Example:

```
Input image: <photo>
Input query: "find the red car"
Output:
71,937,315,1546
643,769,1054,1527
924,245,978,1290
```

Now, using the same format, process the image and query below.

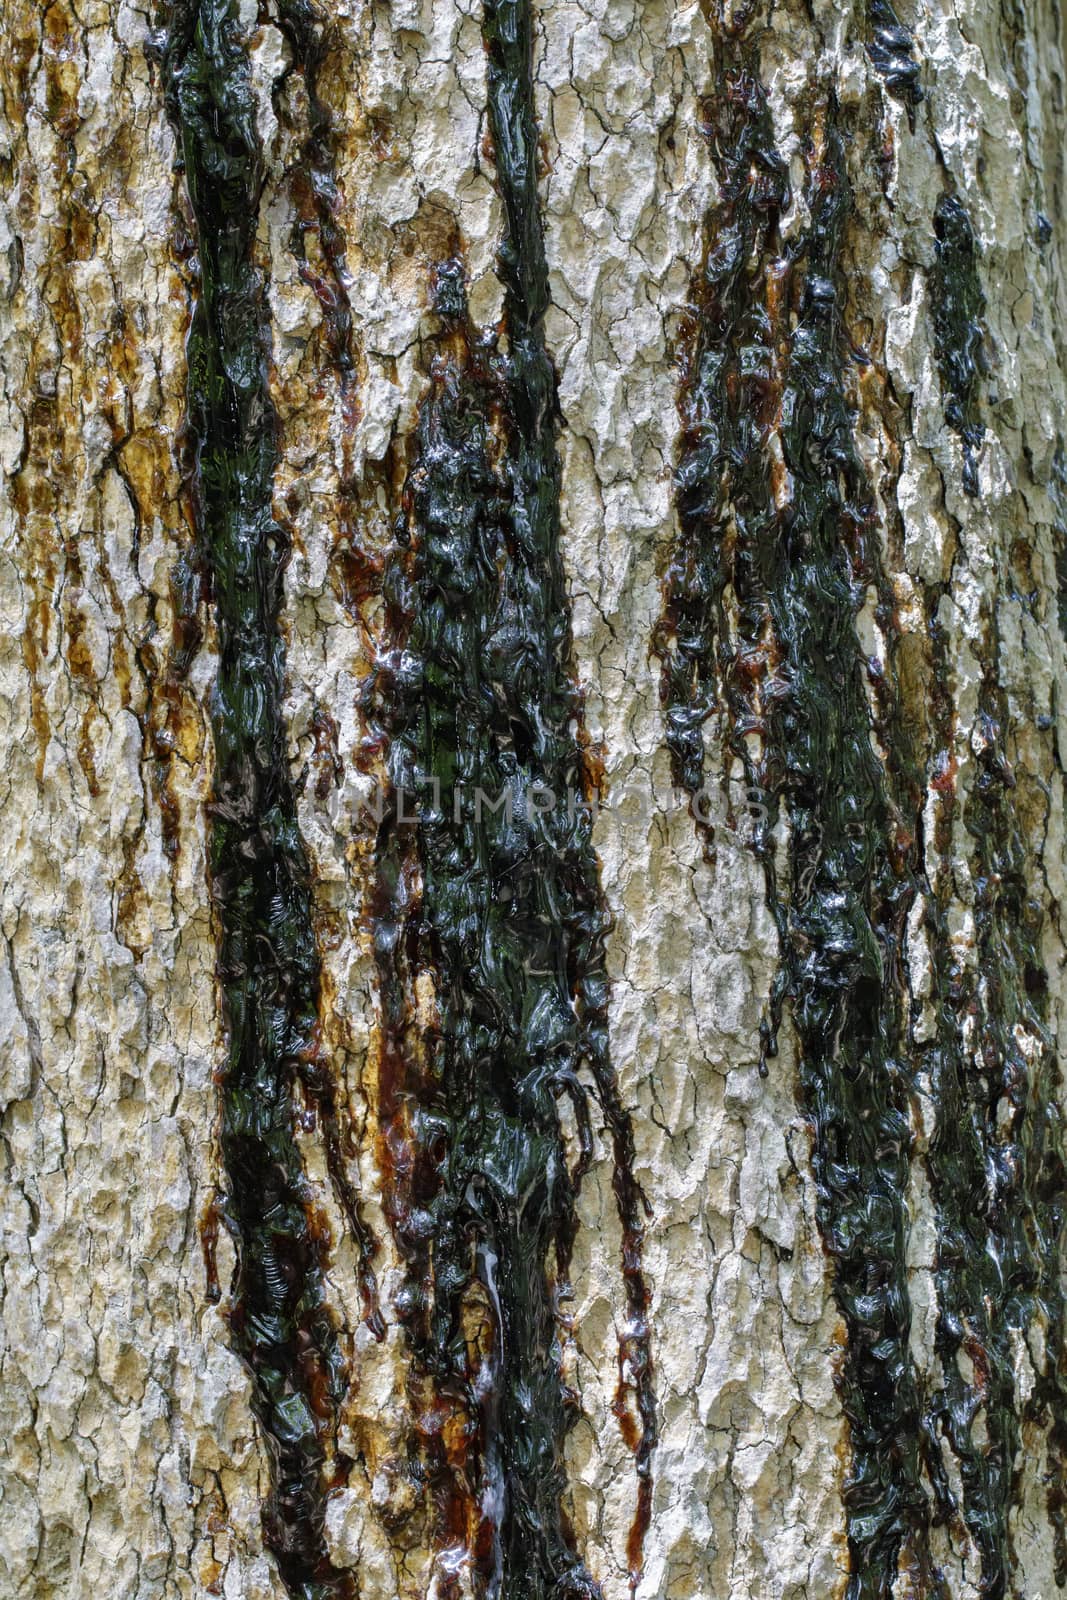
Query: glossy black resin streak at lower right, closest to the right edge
928,598,1067,1600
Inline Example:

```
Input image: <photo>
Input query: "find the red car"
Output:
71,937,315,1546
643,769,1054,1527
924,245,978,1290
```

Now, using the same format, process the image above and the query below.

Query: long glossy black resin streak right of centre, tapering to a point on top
742,117,928,1600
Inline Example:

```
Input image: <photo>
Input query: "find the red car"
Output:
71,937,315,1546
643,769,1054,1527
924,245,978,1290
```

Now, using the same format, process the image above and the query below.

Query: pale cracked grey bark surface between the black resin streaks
0,0,1067,1600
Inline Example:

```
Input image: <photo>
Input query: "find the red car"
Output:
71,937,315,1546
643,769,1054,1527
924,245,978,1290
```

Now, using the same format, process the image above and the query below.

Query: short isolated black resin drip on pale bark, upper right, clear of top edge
929,195,985,494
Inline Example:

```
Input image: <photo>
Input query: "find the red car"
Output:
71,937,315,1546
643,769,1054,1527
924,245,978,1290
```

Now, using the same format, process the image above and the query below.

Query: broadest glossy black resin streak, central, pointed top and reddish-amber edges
373,267,601,1595
